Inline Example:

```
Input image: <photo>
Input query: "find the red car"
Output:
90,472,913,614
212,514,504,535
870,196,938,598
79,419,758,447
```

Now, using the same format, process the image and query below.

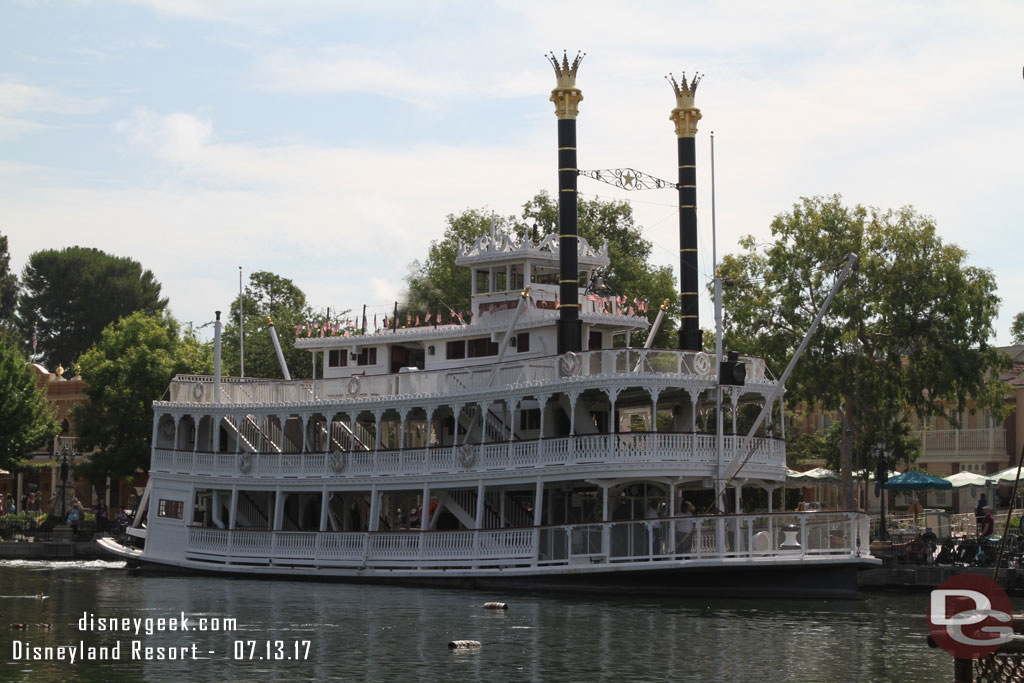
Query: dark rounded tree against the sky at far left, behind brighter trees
17,247,167,367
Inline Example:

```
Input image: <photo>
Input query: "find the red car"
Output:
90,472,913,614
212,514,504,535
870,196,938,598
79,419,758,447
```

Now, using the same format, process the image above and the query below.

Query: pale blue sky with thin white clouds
0,0,1024,344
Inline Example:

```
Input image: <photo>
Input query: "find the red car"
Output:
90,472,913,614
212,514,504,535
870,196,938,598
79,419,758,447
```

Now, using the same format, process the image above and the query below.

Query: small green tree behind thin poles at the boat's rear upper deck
221,270,314,379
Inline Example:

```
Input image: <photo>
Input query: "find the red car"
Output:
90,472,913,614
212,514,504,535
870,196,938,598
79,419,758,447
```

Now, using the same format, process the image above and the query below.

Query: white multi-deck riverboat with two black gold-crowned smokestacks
101,54,878,597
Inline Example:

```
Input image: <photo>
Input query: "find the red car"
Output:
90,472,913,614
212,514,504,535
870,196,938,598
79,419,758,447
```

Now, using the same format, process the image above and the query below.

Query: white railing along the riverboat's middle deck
151,432,785,479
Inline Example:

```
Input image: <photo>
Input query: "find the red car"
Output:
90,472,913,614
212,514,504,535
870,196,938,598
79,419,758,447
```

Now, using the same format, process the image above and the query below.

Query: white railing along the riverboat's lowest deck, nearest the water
186,512,869,570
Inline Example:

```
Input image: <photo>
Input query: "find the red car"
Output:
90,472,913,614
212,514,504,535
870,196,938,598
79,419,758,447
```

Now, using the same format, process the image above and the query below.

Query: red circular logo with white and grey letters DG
928,573,1014,659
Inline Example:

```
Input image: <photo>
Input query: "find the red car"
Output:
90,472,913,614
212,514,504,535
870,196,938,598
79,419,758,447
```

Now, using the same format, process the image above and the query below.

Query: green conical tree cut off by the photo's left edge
0,336,60,468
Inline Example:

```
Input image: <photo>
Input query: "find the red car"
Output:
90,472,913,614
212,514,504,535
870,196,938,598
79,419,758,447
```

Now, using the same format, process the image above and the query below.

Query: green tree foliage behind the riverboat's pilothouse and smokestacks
407,191,679,348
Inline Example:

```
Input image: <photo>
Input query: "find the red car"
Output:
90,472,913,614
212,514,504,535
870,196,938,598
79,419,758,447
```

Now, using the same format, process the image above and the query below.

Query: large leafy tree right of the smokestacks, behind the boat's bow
722,196,1007,506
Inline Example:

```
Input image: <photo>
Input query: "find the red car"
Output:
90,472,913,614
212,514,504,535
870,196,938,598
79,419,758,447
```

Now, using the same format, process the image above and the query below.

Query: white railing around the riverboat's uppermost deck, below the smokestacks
163,348,765,404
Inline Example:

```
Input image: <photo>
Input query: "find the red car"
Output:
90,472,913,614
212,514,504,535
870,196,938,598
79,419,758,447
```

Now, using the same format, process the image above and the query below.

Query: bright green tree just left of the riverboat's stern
72,311,213,481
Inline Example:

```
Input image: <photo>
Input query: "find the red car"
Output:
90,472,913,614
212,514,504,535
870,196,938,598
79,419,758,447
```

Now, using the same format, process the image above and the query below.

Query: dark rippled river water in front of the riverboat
0,561,991,683
